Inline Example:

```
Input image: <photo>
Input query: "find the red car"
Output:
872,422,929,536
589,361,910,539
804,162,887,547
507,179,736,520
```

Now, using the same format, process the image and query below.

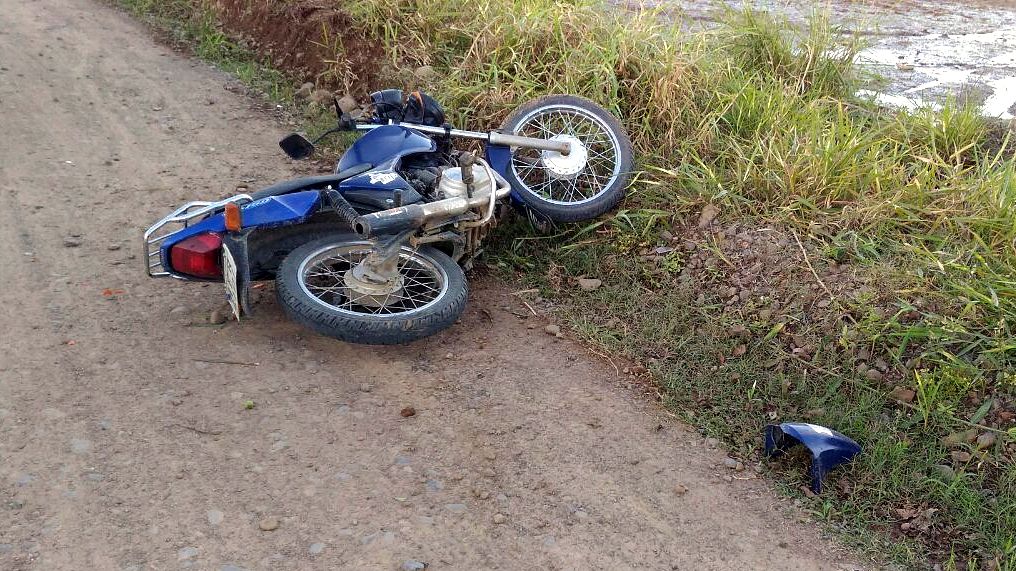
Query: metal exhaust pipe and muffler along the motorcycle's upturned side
353,185,511,238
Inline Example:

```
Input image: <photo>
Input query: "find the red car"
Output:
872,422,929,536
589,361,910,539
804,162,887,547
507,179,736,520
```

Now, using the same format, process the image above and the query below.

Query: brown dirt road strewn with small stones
0,0,858,570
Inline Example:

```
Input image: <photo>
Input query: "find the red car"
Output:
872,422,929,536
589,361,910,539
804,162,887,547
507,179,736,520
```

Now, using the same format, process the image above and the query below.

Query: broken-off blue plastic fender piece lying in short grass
765,423,861,494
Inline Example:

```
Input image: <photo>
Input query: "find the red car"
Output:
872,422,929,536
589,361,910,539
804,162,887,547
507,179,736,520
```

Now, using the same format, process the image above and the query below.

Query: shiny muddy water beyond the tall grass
651,0,1016,120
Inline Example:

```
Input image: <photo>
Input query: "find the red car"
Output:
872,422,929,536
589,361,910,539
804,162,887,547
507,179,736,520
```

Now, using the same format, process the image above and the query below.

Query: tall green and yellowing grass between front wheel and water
345,0,1016,374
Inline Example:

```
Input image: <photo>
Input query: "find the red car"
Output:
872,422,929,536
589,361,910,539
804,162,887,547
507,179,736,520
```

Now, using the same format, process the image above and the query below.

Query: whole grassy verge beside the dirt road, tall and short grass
115,0,1016,570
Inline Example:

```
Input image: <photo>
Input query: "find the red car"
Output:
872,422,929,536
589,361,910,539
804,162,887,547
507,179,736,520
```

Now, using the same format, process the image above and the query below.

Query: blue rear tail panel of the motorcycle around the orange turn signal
160,190,321,267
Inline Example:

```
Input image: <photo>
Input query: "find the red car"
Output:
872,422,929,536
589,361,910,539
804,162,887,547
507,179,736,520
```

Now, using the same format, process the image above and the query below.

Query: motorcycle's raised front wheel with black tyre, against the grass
502,96,633,223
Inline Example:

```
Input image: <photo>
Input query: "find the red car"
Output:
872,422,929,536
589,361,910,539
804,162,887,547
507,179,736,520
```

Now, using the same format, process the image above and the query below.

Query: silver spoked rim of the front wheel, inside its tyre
511,105,621,204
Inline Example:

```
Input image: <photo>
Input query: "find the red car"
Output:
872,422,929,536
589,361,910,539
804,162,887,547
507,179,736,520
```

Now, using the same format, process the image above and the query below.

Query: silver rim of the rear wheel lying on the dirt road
298,242,448,316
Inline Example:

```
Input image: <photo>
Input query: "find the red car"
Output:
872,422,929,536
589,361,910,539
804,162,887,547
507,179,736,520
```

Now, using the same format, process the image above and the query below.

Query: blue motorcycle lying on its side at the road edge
143,89,633,344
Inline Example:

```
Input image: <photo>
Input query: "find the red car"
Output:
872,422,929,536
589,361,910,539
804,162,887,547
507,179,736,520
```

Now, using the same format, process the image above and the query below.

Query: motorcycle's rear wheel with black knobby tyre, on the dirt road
275,234,466,344
